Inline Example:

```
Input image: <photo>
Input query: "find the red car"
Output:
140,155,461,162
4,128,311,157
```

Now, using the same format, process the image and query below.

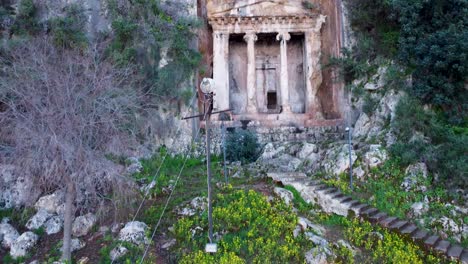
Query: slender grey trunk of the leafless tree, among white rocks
62,179,76,263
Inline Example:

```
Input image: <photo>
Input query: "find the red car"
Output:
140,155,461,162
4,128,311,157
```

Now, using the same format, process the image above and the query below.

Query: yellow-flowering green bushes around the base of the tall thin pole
175,186,311,263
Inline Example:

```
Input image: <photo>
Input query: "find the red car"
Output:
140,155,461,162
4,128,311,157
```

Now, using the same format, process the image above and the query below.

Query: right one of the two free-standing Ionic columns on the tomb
276,32,291,113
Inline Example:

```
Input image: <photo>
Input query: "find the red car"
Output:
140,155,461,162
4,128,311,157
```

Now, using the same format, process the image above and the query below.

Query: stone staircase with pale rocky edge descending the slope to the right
267,172,468,264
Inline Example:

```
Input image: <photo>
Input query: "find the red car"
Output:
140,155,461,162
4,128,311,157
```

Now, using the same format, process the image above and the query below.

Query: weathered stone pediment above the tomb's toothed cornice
207,0,313,17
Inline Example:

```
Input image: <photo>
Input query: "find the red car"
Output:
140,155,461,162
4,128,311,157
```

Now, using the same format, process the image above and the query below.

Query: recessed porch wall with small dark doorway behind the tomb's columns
228,33,306,114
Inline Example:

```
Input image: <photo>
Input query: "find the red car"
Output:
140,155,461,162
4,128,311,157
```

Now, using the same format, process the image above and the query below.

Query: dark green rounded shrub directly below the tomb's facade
226,129,260,163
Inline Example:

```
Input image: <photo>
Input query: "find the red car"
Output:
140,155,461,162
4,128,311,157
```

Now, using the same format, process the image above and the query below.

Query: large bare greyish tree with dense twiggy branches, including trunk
0,38,139,260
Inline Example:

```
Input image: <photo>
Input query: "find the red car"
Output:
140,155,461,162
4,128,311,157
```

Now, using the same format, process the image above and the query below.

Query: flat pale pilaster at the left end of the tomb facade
213,32,229,110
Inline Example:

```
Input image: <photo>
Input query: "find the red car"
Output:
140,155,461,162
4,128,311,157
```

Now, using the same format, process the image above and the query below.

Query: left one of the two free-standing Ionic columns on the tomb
244,32,257,113
